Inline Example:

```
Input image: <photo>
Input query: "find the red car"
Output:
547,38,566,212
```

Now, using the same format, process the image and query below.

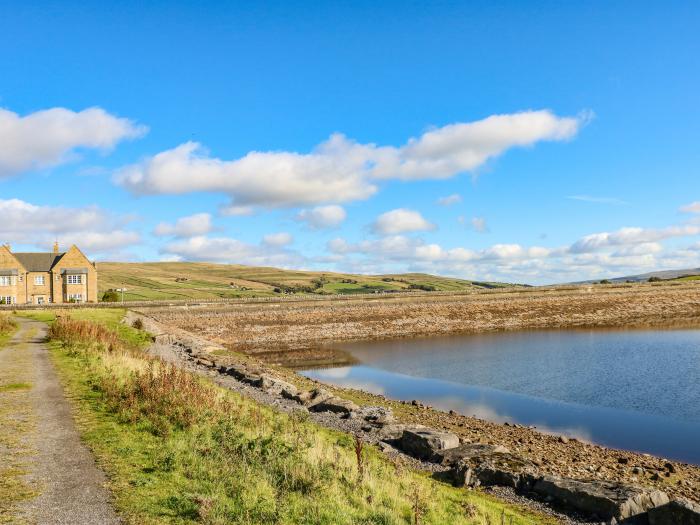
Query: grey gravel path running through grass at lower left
17,318,120,525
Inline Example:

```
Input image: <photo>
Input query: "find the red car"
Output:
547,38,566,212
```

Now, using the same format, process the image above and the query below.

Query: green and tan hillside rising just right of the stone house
97,263,510,301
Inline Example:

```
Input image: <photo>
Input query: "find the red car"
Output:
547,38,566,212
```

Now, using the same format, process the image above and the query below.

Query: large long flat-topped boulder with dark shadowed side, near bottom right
533,476,669,521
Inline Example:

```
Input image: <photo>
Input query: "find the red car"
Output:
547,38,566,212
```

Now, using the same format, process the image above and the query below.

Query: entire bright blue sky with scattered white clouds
0,0,700,284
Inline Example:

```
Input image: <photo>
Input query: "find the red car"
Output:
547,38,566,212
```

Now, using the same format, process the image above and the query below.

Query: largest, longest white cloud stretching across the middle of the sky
115,110,588,208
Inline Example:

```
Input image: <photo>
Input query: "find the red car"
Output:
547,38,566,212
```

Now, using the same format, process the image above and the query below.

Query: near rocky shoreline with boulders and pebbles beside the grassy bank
128,313,700,525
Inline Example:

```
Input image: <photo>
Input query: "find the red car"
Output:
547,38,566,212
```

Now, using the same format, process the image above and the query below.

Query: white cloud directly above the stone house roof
0,199,141,253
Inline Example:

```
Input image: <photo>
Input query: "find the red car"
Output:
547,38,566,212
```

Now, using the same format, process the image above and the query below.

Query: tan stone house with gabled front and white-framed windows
0,243,97,304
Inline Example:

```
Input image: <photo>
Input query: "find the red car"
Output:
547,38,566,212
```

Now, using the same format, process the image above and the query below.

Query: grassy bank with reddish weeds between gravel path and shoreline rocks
42,311,543,524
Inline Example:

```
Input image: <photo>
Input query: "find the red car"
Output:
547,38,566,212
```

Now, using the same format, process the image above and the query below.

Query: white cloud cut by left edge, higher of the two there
0,108,147,178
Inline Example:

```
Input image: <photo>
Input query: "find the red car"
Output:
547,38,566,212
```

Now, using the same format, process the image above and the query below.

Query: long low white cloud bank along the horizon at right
327,221,700,284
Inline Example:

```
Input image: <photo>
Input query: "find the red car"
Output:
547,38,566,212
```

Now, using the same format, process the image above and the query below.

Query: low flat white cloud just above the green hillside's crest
160,236,304,268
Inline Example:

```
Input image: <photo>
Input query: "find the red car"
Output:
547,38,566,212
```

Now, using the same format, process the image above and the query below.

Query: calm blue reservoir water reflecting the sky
302,330,700,464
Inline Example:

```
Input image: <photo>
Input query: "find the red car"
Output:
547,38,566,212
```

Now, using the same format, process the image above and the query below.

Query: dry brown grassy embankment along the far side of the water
145,282,700,352
